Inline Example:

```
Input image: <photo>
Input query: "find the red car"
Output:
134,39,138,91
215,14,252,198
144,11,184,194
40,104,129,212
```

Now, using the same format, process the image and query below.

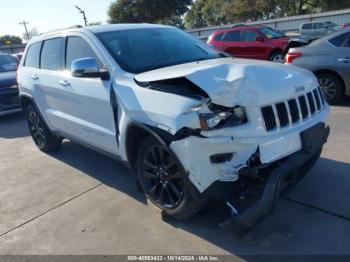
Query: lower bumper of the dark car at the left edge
0,87,21,115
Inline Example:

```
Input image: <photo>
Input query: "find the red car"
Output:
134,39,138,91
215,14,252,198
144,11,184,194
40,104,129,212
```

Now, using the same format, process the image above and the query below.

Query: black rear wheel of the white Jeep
26,105,62,152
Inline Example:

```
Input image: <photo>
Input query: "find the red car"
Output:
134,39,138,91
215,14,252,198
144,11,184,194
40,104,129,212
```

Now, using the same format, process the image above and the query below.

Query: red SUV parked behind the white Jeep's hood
208,26,289,63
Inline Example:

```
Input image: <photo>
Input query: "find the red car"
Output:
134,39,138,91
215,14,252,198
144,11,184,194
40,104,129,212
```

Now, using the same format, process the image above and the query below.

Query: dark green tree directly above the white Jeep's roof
108,0,192,23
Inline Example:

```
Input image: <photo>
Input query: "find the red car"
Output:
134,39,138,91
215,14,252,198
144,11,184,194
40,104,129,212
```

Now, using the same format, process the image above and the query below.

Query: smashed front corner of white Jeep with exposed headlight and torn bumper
136,77,252,193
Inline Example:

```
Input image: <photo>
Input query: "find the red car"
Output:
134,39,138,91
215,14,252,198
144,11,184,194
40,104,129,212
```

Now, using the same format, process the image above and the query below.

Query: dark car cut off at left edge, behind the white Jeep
0,54,21,115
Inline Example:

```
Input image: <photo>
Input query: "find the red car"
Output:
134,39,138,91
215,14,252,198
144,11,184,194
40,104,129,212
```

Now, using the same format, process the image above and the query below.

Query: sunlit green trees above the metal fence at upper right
184,0,350,28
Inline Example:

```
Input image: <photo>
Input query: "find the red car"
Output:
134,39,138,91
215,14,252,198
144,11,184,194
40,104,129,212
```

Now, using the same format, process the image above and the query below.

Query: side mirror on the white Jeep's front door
71,57,110,80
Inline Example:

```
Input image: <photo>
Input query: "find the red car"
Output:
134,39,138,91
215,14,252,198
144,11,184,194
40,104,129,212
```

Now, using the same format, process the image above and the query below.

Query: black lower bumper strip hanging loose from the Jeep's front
224,123,330,231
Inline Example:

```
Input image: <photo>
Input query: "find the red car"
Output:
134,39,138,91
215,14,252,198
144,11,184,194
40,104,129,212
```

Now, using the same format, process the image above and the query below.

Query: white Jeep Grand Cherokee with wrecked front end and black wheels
18,24,329,228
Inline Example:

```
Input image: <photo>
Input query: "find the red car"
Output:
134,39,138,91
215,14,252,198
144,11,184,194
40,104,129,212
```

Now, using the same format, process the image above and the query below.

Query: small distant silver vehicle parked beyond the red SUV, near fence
299,21,339,38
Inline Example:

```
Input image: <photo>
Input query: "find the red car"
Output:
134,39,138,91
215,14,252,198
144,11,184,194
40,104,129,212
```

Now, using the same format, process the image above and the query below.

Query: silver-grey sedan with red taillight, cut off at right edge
286,28,350,104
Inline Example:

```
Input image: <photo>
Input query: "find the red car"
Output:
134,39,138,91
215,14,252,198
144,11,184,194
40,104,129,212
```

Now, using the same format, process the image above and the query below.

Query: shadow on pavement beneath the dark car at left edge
0,113,29,139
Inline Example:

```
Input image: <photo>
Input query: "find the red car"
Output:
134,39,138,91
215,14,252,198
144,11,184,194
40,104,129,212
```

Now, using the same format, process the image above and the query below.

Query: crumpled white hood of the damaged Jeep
135,58,318,107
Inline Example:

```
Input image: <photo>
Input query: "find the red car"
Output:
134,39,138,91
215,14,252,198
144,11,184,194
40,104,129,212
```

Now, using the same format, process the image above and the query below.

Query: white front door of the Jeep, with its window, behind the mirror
58,34,118,154
